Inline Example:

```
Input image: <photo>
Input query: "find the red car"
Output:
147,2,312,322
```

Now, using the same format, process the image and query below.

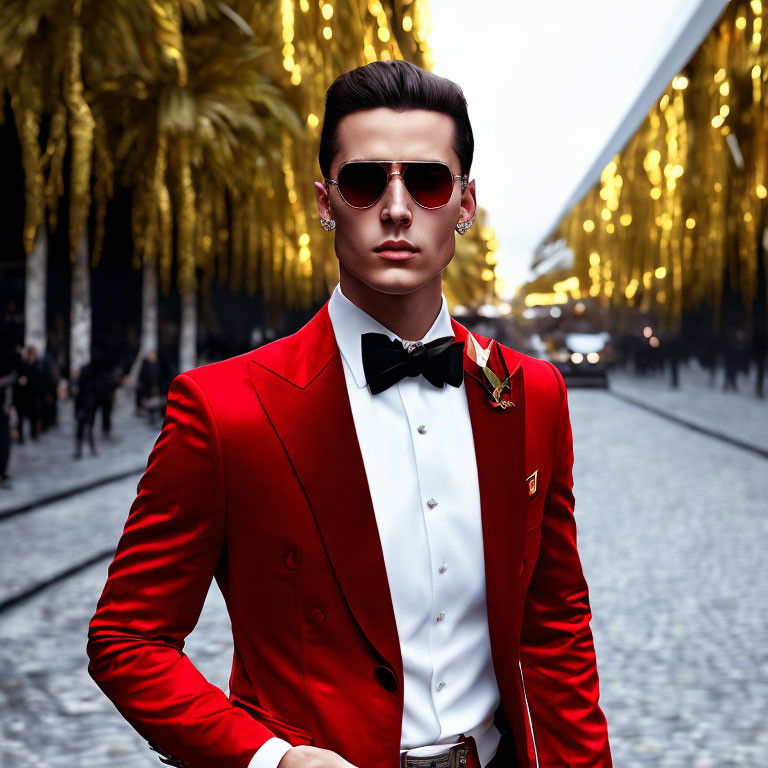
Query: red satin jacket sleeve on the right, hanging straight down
520,364,612,768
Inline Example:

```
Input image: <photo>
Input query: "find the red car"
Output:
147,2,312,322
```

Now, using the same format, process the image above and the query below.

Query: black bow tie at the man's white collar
360,333,464,395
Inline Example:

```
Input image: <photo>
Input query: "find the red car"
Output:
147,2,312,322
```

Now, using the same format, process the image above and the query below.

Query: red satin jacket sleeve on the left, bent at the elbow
87,374,274,768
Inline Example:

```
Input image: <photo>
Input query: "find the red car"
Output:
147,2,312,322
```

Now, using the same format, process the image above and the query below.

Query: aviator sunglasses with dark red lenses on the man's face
325,160,468,209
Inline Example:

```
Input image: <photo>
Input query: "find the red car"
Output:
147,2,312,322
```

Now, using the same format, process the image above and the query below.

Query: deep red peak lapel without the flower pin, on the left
248,302,402,670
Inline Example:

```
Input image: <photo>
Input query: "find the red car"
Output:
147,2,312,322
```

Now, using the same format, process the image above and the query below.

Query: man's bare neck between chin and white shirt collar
339,272,443,341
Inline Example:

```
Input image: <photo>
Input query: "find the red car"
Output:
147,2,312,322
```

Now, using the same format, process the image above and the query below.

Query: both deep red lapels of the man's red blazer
248,302,527,673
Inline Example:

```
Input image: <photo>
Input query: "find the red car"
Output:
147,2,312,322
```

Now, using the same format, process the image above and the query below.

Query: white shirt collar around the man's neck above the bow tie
328,282,455,389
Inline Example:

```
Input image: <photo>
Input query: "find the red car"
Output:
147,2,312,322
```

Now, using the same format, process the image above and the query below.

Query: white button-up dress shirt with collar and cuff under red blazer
249,283,500,768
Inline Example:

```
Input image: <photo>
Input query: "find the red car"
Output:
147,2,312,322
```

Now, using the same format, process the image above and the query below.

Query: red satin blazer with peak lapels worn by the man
88,302,611,768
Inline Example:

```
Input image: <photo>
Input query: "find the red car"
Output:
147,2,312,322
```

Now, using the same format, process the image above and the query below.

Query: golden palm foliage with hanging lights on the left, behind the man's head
0,0,492,318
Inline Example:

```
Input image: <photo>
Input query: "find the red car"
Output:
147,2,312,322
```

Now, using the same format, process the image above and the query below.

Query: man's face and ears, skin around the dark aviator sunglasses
315,107,475,294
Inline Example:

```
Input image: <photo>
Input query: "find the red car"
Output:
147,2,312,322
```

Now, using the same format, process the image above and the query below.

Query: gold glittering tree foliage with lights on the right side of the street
539,0,768,332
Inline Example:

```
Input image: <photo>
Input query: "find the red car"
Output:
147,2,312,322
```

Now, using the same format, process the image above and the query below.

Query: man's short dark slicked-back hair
319,59,475,177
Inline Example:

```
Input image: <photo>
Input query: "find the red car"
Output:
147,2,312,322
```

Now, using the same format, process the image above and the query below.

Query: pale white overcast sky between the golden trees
429,0,724,298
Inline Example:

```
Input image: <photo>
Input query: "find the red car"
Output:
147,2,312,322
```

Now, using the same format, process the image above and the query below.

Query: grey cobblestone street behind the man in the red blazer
0,381,768,768
